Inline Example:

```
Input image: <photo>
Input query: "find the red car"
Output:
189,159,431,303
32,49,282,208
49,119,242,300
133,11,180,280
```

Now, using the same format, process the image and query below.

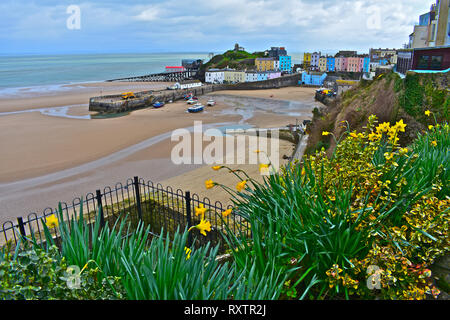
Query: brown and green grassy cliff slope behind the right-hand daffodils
306,73,450,153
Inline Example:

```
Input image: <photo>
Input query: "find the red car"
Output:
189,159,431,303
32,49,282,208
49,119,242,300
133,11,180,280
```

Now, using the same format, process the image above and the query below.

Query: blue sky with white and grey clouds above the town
0,0,434,55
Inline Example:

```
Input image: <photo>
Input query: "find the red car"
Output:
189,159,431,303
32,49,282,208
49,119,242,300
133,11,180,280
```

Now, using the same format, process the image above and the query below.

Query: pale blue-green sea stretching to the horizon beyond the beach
0,52,303,97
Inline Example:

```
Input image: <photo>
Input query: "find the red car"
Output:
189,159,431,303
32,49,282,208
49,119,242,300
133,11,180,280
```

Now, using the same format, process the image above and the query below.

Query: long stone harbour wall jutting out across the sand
89,74,301,113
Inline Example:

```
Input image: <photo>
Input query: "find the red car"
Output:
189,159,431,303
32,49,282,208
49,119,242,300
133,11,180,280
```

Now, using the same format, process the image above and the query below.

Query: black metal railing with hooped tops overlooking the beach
0,177,251,251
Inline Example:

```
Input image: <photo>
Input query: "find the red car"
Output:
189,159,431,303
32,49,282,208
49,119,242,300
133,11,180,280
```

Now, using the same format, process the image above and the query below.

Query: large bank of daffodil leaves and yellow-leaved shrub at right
225,117,450,299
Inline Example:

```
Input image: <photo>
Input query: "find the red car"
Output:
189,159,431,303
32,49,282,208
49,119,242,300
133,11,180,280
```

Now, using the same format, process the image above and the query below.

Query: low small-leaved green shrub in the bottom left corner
0,246,121,300
